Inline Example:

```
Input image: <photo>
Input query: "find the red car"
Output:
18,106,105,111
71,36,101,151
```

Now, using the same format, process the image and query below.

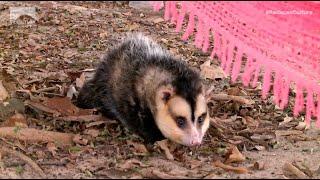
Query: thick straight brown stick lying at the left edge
0,127,75,146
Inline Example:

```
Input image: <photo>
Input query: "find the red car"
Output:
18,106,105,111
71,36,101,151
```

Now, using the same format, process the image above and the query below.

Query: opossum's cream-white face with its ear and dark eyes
155,88,209,146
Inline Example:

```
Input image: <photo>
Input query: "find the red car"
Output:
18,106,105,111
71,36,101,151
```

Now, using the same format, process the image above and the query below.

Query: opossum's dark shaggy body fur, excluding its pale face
77,33,201,142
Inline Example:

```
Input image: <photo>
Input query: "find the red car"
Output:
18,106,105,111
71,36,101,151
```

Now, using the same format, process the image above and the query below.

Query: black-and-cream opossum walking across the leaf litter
76,33,209,146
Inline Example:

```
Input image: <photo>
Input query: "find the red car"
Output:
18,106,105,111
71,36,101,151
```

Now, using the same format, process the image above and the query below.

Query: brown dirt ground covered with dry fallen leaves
0,1,320,178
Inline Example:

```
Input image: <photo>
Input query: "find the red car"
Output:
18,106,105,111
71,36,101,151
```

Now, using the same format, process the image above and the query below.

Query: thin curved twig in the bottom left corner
0,147,46,178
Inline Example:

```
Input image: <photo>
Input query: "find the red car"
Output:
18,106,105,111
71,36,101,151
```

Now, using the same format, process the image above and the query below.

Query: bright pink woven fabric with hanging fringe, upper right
153,1,320,127
